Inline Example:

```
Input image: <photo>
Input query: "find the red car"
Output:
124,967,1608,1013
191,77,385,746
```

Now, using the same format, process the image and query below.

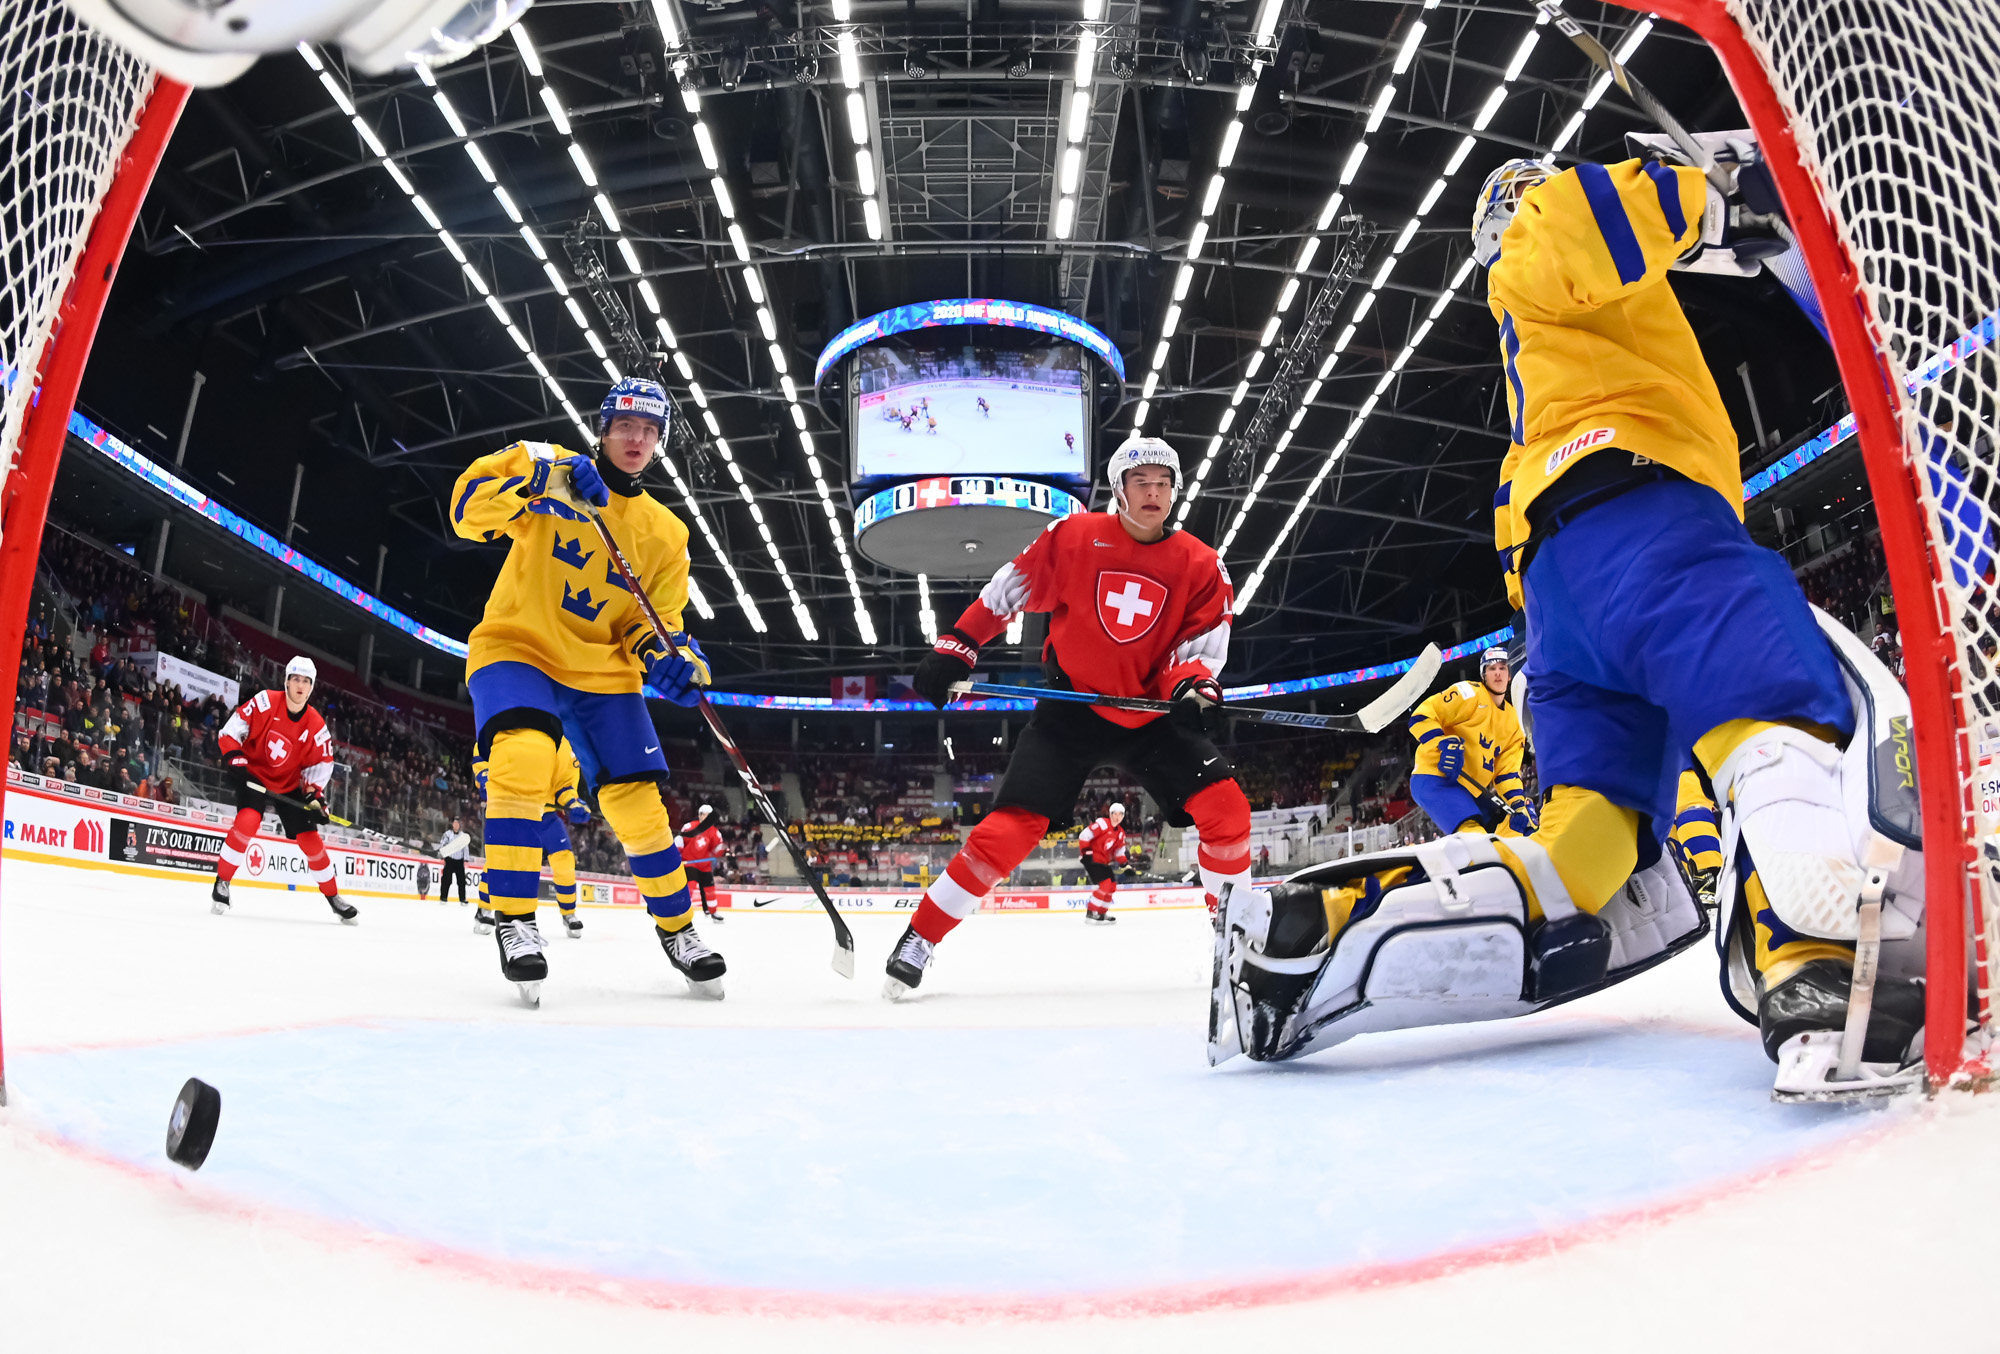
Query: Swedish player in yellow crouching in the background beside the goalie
1410,648,1534,834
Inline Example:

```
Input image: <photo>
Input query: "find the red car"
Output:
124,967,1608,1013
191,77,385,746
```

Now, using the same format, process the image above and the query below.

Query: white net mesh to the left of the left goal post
0,0,154,508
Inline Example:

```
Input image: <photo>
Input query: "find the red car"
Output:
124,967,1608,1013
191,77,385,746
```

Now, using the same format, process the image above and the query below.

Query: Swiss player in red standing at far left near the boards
210,658,360,926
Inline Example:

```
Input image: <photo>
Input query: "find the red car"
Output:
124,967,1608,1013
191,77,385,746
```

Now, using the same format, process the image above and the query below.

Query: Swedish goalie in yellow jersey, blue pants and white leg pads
1230,148,1924,1098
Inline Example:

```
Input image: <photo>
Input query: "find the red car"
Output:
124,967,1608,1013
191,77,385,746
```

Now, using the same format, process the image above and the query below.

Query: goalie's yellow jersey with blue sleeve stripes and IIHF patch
1488,160,1742,606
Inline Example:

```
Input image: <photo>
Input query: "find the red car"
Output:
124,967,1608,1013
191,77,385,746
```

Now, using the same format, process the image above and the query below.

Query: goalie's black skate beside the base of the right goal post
1756,960,1924,1100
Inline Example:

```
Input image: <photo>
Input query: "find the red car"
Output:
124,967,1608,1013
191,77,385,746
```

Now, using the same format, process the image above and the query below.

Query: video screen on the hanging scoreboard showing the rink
854,380,1086,478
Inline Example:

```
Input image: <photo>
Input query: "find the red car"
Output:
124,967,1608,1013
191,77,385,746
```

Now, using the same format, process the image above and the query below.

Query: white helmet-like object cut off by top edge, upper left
68,0,530,86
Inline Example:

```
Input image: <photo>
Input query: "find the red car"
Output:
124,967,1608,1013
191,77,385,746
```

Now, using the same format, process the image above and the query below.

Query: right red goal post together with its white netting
1618,0,2000,1086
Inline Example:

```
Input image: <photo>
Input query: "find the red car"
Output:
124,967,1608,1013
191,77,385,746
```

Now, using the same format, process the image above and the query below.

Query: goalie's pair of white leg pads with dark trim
1210,612,1924,1100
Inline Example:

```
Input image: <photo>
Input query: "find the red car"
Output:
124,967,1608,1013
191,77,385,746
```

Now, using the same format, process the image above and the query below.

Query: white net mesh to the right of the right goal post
1728,0,2000,1014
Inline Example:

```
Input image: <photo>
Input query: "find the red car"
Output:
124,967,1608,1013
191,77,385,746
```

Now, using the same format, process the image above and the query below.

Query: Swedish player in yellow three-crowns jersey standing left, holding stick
450,378,724,1004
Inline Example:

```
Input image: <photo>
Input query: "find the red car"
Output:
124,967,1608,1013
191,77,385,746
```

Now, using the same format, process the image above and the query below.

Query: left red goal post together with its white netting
0,0,188,1104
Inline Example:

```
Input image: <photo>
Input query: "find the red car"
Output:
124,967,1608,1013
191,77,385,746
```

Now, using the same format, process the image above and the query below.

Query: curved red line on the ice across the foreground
24,1104,1896,1326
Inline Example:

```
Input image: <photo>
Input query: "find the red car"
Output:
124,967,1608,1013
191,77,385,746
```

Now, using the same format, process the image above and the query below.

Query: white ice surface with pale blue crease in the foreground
0,860,2000,1350
